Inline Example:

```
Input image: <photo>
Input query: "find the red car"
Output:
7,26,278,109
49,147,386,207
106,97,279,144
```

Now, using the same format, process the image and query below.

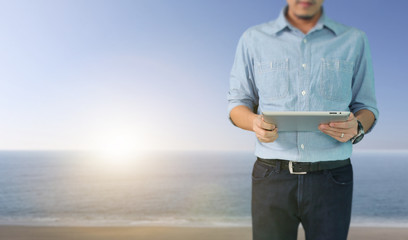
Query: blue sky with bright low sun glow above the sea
0,0,408,151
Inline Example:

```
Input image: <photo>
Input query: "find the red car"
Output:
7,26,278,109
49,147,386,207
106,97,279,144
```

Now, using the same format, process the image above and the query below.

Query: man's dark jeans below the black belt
252,160,353,240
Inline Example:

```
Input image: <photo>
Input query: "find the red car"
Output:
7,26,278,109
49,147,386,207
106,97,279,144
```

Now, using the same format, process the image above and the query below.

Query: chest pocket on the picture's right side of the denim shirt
319,58,354,101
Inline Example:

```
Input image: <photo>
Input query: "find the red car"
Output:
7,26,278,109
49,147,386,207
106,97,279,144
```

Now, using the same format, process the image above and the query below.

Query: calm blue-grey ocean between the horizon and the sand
0,151,408,227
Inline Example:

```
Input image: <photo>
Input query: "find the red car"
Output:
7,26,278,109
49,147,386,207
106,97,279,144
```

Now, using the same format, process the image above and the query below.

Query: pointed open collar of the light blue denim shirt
273,6,340,35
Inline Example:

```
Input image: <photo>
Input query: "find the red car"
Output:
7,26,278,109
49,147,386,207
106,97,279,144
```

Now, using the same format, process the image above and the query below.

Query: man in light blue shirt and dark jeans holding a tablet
228,0,378,240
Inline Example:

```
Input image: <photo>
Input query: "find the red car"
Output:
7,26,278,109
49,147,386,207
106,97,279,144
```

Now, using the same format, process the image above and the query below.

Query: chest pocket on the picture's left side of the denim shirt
255,59,289,100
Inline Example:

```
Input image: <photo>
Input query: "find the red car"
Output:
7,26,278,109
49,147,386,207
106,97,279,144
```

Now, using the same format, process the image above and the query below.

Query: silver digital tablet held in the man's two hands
262,111,350,132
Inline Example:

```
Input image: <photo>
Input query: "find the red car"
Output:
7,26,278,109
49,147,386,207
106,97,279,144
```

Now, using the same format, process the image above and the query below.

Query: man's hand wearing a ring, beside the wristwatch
319,113,358,142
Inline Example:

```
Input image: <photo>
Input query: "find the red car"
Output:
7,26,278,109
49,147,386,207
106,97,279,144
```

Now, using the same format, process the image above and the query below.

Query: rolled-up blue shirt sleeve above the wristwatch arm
350,32,379,133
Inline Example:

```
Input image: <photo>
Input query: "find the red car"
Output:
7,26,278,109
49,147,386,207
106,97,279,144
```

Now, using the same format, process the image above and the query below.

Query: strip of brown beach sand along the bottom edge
0,226,408,240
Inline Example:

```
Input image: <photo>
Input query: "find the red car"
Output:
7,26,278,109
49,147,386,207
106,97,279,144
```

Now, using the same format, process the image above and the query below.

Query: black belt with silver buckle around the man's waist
258,157,351,174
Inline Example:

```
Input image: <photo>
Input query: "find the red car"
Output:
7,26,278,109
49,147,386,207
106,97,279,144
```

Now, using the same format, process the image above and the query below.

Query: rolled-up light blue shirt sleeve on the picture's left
227,33,258,124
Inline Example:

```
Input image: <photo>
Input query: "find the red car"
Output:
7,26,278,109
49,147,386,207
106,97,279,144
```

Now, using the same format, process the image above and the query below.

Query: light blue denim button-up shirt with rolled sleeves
228,9,378,162
